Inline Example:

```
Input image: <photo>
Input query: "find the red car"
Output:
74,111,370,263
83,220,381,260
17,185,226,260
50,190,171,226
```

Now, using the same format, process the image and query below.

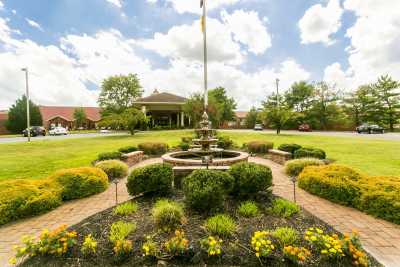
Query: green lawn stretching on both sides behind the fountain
0,131,400,180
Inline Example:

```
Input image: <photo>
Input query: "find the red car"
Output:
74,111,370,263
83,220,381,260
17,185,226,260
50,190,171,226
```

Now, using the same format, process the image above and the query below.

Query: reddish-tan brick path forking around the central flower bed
0,158,400,267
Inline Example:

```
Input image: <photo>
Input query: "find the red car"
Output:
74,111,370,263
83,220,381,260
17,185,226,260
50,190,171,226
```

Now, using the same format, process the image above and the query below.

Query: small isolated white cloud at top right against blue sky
299,0,343,45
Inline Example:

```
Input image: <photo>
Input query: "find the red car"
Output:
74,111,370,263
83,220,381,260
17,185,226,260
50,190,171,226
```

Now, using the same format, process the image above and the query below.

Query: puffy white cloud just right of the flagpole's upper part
221,10,272,54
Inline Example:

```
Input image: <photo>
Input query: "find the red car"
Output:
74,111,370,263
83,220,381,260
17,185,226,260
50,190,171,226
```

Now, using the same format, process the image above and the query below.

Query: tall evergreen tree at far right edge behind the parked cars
372,75,400,131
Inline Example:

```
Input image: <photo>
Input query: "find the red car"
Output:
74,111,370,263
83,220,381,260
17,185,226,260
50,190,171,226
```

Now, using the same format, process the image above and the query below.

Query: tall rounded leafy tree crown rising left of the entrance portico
98,74,143,115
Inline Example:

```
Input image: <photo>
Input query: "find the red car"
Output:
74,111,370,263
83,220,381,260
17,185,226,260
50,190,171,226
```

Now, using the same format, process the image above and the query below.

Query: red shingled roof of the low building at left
39,106,101,122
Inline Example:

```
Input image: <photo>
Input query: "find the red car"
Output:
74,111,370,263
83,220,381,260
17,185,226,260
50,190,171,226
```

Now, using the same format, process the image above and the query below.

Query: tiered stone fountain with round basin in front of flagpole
162,112,249,169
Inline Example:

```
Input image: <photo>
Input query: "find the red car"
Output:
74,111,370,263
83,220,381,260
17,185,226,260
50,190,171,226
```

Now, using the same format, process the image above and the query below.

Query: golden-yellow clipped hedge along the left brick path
0,167,108,225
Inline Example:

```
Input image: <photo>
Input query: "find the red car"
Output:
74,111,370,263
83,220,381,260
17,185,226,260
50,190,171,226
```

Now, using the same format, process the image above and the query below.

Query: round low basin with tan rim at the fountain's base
162,150,249,166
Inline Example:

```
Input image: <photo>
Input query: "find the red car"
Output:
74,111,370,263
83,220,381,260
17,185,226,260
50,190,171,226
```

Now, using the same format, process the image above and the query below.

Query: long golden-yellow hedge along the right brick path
299,164,400,224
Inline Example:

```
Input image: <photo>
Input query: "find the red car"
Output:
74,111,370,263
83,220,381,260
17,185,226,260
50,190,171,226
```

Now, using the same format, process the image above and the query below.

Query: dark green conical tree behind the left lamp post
6,95,43,133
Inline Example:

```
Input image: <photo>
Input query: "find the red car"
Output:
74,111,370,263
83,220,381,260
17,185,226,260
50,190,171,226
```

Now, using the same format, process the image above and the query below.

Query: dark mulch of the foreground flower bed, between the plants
22,191,381,267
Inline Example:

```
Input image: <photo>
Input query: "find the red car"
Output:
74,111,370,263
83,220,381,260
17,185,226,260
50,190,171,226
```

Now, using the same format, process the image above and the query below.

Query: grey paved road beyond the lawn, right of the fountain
221,129,400,141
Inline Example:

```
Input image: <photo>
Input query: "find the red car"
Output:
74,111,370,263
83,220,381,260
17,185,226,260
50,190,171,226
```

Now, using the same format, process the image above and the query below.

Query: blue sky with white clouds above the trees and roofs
0,0,400,110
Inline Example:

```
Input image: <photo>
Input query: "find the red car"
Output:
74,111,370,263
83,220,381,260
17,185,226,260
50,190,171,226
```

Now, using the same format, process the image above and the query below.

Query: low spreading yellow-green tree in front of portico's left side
99,108,148,135
